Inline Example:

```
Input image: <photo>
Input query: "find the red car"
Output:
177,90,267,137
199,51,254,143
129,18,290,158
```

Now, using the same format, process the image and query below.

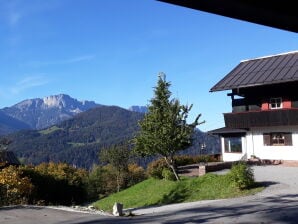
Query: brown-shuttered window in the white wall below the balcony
263,132,292,146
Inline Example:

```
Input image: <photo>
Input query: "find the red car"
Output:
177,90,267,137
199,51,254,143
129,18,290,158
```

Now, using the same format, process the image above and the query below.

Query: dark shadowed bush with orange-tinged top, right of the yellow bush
22,162,88,205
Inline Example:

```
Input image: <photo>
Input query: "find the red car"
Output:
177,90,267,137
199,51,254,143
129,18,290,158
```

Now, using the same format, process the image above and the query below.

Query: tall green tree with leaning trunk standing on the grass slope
133,73,204,180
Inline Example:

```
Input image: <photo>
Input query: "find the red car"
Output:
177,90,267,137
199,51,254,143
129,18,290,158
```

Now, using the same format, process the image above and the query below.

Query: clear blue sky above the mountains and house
0,0,298,131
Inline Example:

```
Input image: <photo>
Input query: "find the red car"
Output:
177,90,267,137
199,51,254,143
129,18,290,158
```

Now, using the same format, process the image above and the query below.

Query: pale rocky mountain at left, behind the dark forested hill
0,94,100,134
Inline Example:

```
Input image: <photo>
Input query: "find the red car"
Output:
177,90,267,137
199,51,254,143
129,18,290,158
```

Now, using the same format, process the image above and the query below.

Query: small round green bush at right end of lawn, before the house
228,162,255,190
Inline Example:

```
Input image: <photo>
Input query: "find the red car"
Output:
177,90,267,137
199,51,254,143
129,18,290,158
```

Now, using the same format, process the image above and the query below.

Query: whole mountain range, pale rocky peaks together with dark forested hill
0,94,219,169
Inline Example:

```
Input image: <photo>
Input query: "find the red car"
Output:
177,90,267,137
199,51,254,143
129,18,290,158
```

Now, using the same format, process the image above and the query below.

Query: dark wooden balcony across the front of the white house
224,108,298,128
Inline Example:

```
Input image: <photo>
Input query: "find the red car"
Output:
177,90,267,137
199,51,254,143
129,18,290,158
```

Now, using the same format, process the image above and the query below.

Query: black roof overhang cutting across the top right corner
158,0,298,33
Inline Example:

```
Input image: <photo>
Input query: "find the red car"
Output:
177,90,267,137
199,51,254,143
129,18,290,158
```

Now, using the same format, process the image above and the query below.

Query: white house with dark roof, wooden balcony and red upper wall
210,51,298,161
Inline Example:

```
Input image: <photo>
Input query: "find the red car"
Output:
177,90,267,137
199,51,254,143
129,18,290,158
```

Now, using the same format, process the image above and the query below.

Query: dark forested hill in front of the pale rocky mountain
7,106,219,168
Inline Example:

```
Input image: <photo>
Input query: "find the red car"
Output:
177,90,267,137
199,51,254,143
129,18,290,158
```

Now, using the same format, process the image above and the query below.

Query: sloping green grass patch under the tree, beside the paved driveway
93,173,263,211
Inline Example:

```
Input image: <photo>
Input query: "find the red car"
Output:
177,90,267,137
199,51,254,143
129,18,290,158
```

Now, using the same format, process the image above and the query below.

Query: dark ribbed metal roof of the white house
210,51,298,92
